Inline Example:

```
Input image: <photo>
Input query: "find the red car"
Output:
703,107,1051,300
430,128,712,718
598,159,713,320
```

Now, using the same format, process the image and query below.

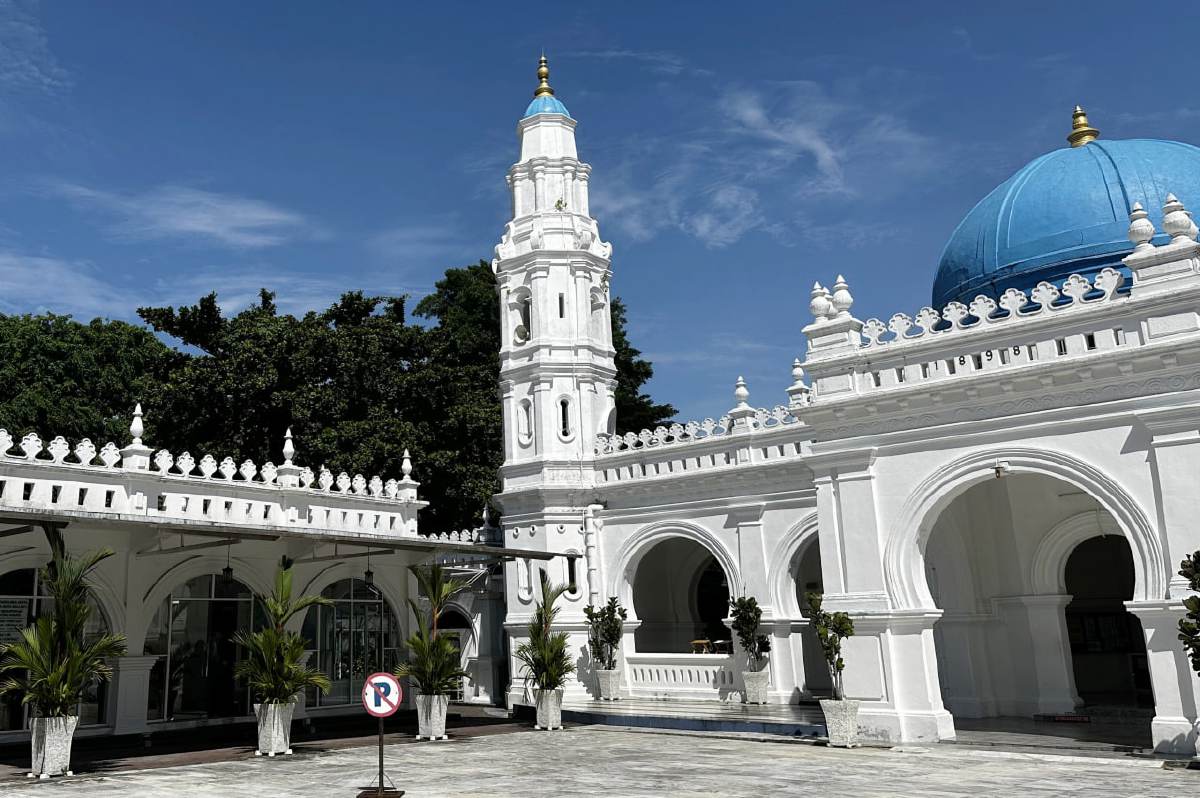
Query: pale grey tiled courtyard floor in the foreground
2,726,1200,798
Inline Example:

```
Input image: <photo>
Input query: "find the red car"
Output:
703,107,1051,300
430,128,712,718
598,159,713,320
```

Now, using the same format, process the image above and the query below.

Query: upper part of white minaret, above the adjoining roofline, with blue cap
492,55,617,484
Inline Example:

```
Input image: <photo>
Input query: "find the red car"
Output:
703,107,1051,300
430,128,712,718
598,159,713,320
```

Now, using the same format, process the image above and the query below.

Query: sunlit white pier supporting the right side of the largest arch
1126,601,1200,755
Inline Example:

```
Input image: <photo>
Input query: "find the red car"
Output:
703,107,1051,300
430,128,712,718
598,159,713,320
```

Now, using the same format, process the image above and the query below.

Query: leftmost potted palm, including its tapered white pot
0,533,125,779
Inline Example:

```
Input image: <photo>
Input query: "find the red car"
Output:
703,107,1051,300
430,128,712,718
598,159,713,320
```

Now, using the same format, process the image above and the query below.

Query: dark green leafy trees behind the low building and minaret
0,262,676,529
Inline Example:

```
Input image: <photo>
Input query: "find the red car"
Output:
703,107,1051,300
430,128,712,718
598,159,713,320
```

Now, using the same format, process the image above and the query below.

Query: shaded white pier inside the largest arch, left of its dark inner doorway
995,595,1082,715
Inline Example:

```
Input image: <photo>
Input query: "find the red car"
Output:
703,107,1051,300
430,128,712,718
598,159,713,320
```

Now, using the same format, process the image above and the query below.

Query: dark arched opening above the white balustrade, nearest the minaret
632,536,730,653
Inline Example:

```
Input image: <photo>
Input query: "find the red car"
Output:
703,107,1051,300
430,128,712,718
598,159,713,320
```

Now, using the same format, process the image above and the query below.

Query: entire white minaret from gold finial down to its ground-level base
492,55,617,702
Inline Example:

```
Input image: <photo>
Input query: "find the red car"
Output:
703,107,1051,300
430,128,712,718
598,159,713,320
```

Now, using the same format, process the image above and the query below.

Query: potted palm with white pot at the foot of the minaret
515,576,575,730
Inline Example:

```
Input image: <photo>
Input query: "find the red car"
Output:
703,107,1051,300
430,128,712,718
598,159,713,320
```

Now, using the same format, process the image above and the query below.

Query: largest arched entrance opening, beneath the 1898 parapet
923,472,1150,743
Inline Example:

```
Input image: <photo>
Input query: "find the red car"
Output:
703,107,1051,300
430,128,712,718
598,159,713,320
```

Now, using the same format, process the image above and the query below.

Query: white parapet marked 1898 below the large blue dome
804,196,1200,405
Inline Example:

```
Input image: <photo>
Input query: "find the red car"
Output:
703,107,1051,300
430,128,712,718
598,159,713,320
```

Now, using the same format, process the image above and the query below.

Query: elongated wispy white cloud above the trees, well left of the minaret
47,181,320,250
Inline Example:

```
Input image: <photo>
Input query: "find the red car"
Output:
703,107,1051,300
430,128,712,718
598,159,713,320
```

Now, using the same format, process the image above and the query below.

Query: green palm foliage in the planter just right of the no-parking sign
396,565,468,696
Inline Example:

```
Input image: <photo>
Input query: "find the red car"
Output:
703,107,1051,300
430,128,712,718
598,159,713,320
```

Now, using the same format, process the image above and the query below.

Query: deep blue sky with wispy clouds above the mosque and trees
0,0,1200,418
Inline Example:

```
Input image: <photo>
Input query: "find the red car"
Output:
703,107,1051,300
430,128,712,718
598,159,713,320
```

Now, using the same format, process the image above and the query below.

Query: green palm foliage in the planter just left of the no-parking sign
234,558,334,703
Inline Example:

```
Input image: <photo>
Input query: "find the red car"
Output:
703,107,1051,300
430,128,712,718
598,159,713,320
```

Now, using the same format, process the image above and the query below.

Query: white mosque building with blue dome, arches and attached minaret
493,61,1200,751
